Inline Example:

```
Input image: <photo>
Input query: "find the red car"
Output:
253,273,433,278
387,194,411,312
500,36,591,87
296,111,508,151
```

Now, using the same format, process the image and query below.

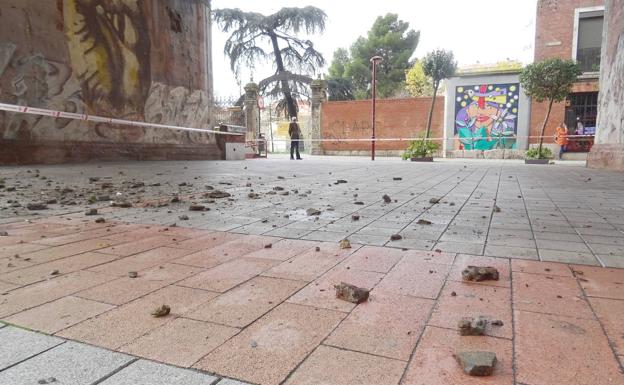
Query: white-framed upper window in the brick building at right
572,7,604,72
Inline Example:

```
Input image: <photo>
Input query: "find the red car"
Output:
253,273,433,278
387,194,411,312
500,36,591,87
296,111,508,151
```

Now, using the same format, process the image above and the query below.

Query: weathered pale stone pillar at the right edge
588,0,624,170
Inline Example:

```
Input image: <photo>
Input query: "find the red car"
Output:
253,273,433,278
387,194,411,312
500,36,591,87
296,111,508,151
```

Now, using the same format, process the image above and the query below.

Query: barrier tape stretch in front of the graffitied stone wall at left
0,103,244,136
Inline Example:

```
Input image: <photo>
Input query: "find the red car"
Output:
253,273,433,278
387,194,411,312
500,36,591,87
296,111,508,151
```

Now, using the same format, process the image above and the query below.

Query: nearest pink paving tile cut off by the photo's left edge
0,271,111,317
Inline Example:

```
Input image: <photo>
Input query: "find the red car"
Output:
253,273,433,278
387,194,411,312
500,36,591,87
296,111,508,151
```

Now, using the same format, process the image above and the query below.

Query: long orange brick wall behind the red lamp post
321,96,444,151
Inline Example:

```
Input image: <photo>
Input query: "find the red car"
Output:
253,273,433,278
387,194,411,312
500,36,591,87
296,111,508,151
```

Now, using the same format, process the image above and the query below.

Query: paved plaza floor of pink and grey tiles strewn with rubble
0,158,624,385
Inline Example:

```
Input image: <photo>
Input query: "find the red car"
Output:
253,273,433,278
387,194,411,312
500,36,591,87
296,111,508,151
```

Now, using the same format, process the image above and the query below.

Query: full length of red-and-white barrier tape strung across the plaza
0,103,594,143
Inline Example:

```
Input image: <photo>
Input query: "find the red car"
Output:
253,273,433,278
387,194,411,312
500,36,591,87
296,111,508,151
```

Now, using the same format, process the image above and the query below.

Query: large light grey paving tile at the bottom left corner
0,342,132,385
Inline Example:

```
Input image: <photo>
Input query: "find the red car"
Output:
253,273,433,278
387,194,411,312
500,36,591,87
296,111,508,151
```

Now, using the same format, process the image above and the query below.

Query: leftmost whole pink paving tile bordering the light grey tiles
6,296,114,334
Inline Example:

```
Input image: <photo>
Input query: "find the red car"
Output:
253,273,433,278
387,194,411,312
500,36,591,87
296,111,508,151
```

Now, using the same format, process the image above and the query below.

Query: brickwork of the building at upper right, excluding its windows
530,0,604,143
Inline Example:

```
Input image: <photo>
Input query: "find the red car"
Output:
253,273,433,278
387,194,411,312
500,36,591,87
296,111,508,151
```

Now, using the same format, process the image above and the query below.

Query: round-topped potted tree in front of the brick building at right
520,59,582,164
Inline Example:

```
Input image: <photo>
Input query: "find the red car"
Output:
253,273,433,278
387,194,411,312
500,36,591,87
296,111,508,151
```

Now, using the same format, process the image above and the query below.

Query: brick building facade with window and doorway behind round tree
530,0,605,152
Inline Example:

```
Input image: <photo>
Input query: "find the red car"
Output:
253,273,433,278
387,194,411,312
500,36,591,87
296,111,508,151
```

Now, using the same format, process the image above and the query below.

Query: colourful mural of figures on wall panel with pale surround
445,74,530,155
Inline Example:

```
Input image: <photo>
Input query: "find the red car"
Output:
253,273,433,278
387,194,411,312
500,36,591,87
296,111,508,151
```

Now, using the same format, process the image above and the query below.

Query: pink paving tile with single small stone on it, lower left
58,286,216,349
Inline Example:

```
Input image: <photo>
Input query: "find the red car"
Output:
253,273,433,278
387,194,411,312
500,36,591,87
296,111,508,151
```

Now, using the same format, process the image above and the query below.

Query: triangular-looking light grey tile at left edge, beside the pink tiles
0,324,63,368
